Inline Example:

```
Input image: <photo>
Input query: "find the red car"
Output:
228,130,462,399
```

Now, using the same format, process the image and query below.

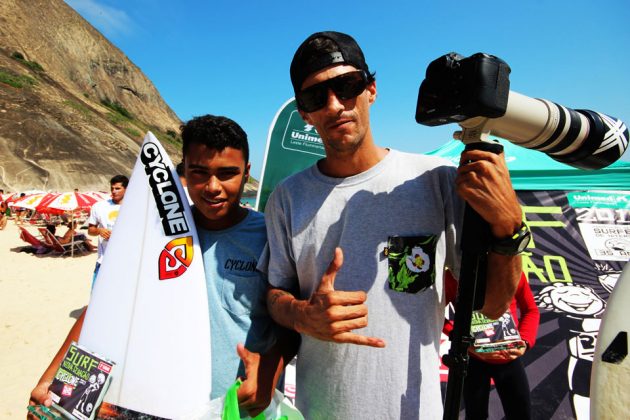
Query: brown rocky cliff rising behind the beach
0,0,181,191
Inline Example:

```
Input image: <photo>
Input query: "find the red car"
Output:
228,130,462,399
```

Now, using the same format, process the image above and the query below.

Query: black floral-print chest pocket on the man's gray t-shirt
385,235,437,293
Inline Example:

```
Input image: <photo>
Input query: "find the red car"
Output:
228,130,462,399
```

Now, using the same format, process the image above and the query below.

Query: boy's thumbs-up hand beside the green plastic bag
236,343,274,418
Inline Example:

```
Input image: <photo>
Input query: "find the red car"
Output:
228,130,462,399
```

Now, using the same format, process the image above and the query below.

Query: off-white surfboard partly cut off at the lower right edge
591,264,630,420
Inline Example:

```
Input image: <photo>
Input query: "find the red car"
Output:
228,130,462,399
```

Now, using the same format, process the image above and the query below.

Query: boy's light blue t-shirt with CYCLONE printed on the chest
197,210,276,399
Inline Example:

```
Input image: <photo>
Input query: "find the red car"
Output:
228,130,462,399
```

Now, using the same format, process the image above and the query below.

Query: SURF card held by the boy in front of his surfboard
49,342,114,420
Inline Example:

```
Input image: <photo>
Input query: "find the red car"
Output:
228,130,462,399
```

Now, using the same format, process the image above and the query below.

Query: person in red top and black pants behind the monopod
443,271,540,420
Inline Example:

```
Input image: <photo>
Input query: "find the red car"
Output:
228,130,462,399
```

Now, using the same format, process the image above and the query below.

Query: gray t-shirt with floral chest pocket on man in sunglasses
259,150,464,419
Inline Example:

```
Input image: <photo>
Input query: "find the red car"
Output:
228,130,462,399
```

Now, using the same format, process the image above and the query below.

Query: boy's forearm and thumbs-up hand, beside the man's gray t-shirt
236,327,300,417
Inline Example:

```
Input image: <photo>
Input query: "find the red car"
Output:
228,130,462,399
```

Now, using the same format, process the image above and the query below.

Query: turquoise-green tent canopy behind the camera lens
426,140,630,191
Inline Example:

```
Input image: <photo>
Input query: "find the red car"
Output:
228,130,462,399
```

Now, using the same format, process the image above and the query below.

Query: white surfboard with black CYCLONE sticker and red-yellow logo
79,132,211,418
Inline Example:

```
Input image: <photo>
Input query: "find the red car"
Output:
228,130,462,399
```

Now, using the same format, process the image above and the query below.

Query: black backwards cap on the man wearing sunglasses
291,31,370,93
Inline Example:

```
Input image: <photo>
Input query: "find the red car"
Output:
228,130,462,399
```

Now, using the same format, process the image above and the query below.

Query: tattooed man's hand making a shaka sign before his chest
294,248,385,347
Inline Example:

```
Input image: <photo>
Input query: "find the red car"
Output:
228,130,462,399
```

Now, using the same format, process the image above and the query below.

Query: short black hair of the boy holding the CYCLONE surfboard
180,115,249,164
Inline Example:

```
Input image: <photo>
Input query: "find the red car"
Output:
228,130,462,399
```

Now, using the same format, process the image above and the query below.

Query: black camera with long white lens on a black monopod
416,53,629,419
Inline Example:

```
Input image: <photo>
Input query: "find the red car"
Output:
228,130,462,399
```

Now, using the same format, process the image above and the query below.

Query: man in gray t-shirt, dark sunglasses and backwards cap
259,32,521,419
